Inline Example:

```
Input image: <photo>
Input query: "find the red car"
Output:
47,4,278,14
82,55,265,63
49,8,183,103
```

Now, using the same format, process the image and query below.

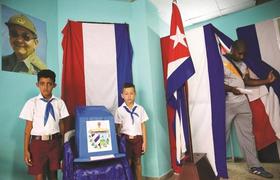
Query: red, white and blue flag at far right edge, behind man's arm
237,18,280,156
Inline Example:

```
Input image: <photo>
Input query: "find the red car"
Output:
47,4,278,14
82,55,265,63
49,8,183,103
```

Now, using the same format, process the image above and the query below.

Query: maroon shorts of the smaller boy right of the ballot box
124,135,143,159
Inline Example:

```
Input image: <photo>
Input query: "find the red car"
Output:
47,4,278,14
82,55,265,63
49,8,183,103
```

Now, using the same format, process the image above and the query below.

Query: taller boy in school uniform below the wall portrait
19,69,69,180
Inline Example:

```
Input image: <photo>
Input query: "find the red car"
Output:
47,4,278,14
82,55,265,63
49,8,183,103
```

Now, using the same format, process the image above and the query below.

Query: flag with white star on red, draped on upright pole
161,2,195,172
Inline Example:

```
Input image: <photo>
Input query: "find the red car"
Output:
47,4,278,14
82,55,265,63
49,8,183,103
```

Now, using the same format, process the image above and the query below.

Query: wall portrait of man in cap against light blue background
1,5,47,74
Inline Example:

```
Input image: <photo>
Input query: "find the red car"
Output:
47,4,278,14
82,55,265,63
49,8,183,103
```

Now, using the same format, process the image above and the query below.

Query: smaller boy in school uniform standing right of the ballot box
115,83,149,180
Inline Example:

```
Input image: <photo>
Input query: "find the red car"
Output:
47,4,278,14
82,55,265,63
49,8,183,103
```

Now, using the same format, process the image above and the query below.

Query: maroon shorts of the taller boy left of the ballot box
28,137,62,175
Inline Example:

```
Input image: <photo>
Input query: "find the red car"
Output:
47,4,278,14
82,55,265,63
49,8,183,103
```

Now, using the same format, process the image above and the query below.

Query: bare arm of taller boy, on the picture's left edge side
24,121,32,166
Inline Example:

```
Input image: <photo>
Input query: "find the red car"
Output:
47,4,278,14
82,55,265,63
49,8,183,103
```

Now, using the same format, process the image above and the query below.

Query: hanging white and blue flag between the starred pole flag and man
164,24,233,178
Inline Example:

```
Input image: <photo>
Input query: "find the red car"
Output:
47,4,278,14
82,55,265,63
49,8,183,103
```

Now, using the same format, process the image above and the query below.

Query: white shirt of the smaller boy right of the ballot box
115,103,149,136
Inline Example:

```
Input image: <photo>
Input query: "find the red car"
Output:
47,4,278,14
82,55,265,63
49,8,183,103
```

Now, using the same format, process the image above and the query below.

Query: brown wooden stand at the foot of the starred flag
179,153,217,180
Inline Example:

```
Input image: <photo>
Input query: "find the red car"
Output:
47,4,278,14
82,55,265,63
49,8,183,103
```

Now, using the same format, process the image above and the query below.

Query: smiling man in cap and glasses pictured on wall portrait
2,14,47,74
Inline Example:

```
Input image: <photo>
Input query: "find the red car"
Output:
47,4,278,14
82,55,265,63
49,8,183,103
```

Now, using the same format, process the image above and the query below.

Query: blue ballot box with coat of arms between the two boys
74,106,125,162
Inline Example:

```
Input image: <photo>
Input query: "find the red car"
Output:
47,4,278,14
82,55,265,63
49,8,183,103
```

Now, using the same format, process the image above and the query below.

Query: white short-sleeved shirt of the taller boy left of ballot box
19,94,69,136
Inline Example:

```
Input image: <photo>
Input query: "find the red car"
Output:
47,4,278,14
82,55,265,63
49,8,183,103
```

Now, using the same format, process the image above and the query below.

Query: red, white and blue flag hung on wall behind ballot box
62,21,133,129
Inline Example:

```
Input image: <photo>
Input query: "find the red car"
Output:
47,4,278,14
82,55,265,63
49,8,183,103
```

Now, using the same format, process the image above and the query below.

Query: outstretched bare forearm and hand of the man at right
243,71,276,86
